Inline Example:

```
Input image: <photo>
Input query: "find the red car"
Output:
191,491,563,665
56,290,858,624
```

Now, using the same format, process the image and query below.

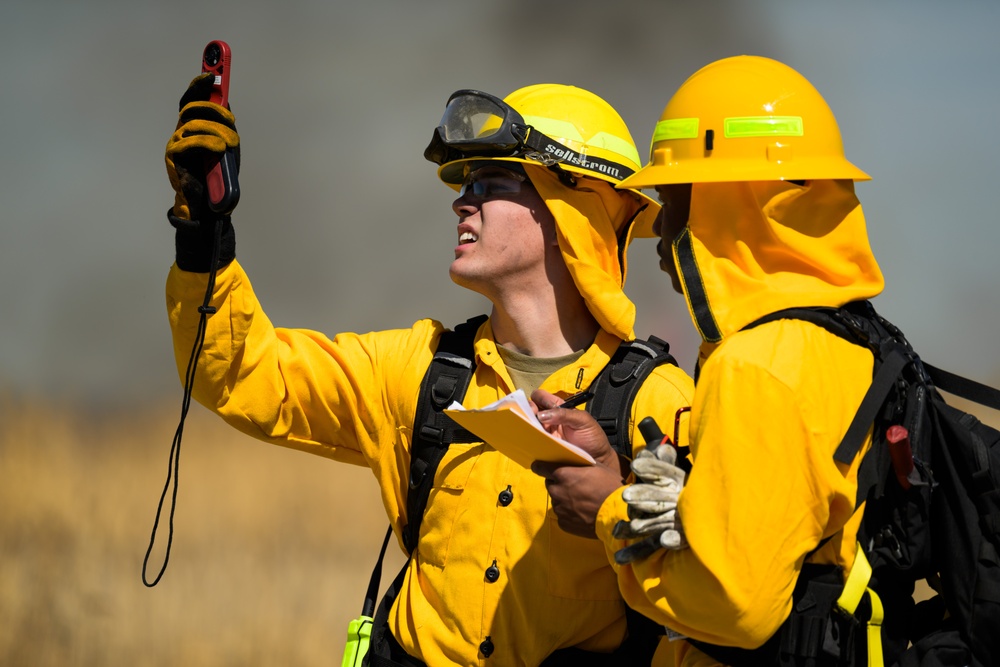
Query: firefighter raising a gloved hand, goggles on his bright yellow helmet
166,78,693,667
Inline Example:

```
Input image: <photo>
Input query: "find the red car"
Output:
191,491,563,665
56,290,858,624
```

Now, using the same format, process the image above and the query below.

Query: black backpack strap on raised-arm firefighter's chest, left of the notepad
403,315,486,553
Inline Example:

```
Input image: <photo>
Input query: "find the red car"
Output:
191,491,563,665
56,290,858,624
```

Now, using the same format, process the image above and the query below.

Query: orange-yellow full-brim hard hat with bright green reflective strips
621,56,871,188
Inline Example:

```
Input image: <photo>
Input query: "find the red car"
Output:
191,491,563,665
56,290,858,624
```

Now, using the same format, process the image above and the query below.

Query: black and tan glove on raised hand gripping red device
165,74,240,273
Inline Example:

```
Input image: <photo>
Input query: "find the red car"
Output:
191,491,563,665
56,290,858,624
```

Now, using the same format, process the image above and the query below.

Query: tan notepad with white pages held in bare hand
444,389,594,468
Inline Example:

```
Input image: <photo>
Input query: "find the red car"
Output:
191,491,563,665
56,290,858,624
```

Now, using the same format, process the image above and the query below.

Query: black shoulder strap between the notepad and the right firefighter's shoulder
587,336,677,458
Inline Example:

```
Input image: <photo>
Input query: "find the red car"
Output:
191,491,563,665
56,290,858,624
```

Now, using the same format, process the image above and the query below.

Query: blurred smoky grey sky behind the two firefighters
0,0,1000,407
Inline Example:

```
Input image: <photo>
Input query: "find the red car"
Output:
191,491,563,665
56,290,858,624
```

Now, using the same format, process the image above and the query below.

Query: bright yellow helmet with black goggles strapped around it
424,83,641,189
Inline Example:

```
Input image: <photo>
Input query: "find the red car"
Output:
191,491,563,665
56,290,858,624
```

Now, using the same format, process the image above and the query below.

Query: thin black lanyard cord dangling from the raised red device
142,218,223,588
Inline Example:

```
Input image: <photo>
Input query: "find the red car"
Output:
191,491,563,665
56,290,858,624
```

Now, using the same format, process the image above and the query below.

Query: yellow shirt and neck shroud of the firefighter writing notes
597,181,883,667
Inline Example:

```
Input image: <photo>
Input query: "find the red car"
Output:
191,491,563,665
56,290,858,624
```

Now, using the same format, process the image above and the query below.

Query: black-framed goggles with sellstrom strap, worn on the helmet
424,90,633,184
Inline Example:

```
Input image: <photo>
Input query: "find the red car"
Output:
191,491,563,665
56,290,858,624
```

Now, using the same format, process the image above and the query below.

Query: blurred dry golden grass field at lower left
0,398,1000,667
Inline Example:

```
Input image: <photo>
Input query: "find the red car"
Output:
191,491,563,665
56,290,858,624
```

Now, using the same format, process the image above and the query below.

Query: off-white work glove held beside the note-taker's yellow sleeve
612,444,687,565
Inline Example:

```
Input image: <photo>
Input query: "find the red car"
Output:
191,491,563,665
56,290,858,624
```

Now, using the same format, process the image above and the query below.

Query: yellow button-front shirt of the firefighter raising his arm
167,261,693,667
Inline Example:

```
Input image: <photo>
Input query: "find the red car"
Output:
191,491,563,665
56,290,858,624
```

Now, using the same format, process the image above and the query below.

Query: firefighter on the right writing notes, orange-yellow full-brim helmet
536,56,883,666
